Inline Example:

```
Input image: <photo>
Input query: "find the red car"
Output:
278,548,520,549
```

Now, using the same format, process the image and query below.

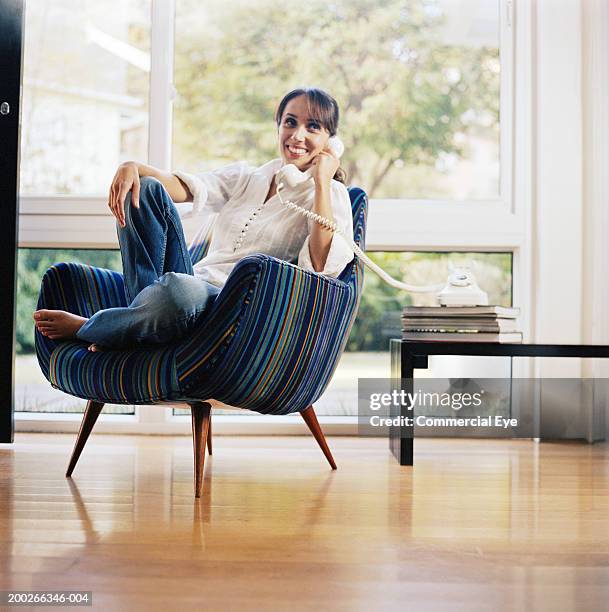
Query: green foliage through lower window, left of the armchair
16,249,122,353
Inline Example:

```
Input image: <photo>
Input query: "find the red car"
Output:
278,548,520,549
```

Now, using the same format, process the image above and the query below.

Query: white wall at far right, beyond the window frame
531,0,609,376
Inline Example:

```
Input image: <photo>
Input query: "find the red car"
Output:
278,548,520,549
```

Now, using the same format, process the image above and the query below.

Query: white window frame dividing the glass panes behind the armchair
15,0,533,434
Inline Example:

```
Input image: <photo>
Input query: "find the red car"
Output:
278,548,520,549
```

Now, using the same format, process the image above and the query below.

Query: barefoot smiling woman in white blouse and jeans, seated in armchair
34,88,353,351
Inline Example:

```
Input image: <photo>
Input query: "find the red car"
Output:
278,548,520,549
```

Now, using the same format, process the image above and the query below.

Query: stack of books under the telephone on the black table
402,306,522,344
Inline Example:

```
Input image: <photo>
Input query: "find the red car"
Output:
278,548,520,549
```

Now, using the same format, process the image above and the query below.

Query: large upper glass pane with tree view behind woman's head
173,0,500,200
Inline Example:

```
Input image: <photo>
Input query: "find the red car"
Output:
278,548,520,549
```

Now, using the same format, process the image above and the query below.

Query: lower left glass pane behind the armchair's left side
15,249,135,414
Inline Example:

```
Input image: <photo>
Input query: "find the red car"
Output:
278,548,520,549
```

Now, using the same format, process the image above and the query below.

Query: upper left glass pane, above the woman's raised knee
20,0,150,195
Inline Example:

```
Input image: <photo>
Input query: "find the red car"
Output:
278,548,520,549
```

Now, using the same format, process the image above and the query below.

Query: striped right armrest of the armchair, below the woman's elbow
176,254,357,413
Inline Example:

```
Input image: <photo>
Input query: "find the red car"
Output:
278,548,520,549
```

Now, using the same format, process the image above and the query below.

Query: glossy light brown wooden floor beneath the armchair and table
0,434,609,612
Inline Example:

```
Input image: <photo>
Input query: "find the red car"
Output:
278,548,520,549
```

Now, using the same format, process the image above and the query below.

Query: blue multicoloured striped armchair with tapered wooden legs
36,187,367,497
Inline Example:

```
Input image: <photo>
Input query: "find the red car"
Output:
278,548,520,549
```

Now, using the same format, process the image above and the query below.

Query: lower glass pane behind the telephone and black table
315,252,512,415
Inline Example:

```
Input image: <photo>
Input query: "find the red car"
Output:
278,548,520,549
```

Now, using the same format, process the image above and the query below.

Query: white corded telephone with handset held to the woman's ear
277,136,488,306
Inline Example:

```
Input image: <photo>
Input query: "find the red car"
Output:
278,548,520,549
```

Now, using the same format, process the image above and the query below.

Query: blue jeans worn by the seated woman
76,177,220,348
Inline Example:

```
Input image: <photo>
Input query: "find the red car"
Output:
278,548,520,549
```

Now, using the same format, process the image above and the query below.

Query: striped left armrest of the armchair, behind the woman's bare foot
38,263,127,317
